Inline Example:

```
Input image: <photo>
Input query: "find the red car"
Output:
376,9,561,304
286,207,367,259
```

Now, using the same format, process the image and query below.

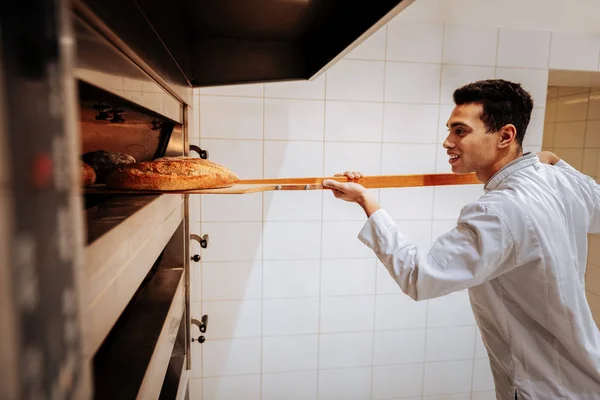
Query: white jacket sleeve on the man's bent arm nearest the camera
358,202,516,300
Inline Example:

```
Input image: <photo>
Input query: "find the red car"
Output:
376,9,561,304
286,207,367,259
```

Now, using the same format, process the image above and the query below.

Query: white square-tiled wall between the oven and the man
192,3,600,400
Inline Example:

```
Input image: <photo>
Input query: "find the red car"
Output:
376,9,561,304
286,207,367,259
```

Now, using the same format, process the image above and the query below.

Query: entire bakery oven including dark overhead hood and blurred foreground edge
0,0,413,400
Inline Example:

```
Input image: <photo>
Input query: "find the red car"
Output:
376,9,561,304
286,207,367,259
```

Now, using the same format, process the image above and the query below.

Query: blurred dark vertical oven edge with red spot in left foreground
0,0,90,400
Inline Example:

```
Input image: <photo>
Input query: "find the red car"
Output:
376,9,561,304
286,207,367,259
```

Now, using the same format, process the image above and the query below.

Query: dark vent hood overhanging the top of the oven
75,0,414,87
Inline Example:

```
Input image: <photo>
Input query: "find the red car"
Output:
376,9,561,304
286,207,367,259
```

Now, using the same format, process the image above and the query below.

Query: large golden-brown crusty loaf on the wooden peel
106,157,239,191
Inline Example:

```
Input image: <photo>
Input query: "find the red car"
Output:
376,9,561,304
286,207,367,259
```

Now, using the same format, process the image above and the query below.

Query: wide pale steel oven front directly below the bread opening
82,195,184,358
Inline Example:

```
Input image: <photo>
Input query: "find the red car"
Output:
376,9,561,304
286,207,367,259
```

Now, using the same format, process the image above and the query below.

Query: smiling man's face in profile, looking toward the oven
444,103,499,175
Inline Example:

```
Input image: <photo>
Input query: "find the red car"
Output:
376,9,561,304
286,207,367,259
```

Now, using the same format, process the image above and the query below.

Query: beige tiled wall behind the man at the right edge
542,86,600,325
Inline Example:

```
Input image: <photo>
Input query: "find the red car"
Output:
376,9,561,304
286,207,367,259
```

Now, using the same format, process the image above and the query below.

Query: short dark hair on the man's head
452,79,533,145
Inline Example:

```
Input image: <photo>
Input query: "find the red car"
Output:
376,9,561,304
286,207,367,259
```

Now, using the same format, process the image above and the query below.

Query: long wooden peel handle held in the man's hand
239,174,481,190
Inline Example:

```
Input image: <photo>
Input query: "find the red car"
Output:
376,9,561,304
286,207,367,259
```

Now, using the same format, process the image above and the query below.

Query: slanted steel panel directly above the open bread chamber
74,16,183,123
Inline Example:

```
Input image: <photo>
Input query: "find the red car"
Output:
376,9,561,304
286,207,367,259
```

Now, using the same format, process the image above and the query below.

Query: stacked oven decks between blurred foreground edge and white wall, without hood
73,5,191,399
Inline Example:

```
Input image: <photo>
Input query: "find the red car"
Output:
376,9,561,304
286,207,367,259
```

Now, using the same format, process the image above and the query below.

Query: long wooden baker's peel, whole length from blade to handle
85,174,481,194
